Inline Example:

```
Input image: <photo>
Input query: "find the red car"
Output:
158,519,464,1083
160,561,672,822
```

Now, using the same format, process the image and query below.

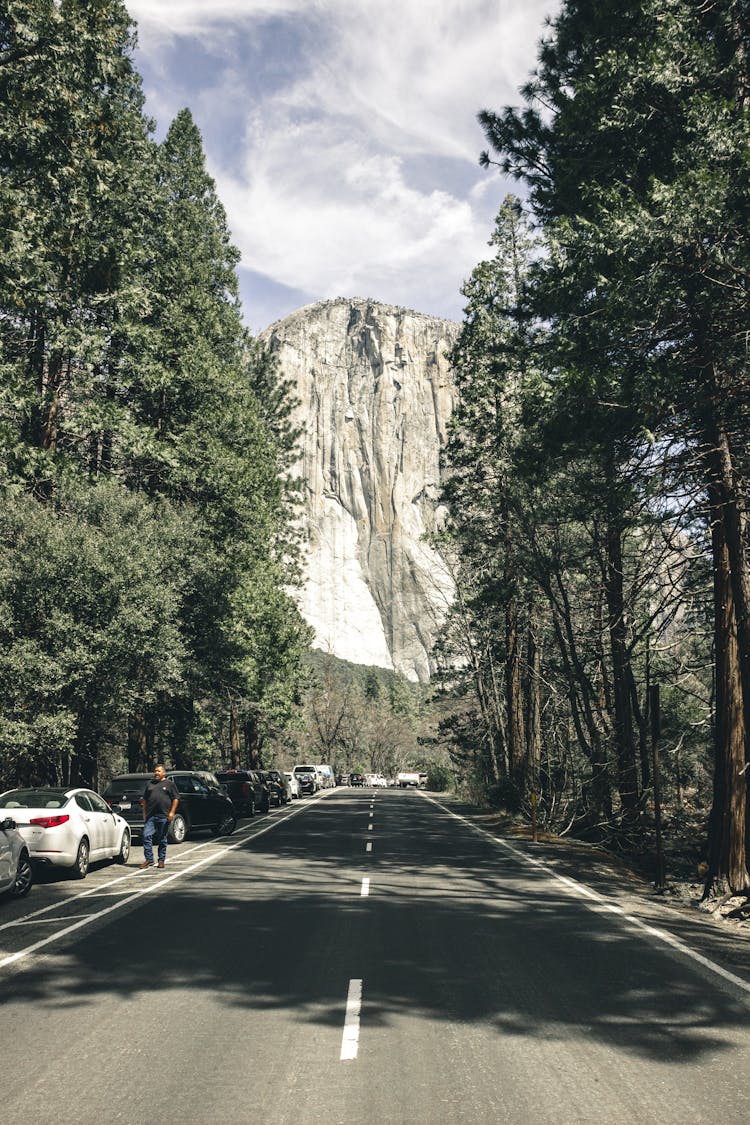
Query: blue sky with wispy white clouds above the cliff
126,0,557,333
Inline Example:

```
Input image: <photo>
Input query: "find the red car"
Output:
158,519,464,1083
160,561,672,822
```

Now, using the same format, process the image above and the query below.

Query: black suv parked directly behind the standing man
102,770,237,844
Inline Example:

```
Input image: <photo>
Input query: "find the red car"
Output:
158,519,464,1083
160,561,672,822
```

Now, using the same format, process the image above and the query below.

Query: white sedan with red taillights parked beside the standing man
0,786,130,879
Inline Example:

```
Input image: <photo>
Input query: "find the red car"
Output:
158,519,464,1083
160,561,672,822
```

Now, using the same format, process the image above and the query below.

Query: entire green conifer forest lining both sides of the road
0,0,750,893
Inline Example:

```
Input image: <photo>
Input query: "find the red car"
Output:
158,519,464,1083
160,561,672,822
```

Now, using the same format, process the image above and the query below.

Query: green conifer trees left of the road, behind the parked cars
0,0,308,784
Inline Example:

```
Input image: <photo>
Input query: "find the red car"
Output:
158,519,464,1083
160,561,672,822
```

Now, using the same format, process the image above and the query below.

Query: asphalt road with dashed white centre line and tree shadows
0,790,750,1125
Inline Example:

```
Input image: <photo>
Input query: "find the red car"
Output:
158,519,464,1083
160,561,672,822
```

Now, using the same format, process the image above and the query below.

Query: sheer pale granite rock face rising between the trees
262,298,458,681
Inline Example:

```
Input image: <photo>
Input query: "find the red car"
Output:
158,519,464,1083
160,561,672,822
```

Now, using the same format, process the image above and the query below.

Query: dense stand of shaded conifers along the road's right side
434,0,750,893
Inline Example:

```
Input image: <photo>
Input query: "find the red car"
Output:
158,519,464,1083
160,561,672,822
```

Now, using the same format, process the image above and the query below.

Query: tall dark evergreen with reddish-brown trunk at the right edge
481,0,750,890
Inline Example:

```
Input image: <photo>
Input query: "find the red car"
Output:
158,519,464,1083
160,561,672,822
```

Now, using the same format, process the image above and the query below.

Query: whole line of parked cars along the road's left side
0,765,333,898
